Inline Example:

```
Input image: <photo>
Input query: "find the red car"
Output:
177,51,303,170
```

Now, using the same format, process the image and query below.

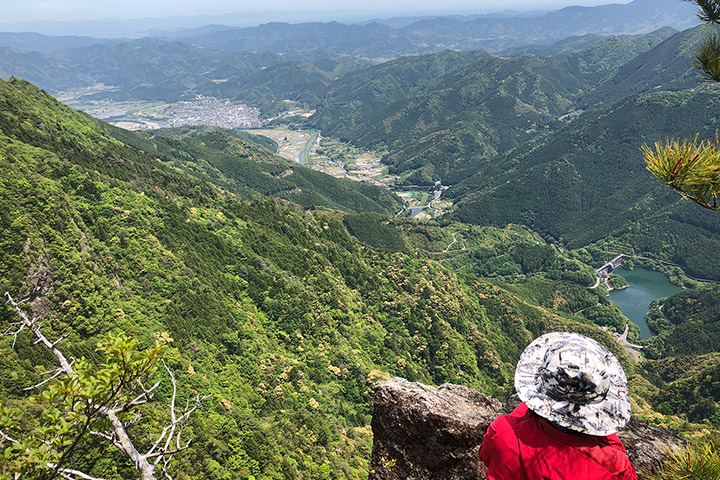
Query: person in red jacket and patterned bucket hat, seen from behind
480,332,637,480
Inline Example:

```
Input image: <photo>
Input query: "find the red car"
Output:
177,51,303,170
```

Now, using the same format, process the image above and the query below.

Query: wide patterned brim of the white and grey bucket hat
515,332,630,436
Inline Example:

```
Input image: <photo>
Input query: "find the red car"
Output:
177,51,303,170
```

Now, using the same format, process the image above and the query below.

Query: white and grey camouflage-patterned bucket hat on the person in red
515,332,630,436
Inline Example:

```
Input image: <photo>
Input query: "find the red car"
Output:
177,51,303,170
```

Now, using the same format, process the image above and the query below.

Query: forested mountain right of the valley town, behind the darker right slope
309,30,671,184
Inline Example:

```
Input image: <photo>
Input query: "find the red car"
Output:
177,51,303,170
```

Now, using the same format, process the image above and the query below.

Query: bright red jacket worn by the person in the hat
480,403,637,480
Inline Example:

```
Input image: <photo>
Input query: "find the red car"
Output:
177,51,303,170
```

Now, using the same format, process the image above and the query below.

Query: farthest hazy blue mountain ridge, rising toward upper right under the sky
181,0,697,58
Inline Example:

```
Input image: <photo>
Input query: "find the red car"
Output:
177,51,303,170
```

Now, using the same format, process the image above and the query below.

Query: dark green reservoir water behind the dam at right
610,268,681,338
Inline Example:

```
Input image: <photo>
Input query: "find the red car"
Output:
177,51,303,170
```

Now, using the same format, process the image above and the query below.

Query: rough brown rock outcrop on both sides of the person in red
370,378,684,480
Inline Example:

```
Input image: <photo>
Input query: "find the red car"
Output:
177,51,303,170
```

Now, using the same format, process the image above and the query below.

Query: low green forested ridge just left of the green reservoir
345,213,637,336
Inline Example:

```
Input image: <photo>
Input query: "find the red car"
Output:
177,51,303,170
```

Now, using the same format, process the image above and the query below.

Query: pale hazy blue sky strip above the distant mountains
0,0,630,23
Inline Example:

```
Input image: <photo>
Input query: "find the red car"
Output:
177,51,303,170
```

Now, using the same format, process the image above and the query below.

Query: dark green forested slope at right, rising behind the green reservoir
448,86,720,278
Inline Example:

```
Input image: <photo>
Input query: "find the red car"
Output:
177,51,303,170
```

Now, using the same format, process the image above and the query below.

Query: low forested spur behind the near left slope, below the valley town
106,127,402,214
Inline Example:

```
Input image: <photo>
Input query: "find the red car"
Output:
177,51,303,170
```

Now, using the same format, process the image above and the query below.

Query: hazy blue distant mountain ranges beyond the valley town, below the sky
0,0,696,111
